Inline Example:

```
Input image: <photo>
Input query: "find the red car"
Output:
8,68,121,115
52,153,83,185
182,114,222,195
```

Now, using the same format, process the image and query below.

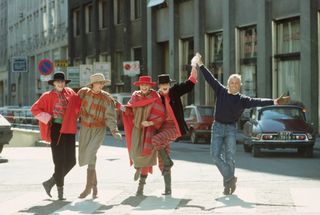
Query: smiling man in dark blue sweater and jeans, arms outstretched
191,53,290,195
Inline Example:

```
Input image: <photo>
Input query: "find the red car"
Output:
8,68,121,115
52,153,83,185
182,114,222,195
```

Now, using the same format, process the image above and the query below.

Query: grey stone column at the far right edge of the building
300,0,319,129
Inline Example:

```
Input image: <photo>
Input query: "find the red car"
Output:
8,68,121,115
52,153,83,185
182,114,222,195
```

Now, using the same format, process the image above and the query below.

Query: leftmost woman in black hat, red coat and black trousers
31,72,81,200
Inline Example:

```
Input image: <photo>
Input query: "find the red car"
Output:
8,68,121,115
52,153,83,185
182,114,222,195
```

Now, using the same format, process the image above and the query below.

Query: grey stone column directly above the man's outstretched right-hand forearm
257,0,272,98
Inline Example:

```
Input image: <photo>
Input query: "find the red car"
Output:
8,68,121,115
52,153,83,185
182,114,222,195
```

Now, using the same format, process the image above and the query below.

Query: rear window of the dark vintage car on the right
259,107,304,120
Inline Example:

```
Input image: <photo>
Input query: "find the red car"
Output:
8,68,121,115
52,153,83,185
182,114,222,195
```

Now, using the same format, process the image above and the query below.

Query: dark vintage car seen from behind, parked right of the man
243,105,315,157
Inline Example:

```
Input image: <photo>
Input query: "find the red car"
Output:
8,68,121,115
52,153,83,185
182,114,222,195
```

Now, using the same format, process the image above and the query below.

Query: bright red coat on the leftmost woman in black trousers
31,87,81,142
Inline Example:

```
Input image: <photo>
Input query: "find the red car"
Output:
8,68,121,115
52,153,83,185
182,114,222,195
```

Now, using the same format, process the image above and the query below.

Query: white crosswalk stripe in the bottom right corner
290,188,320,213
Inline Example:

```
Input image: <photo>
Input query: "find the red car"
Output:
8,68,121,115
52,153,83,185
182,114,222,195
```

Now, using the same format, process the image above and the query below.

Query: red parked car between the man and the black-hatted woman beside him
184,105,214,144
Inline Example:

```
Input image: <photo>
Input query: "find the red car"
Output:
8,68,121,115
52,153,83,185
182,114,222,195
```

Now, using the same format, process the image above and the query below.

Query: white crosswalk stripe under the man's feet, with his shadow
214,188,256,214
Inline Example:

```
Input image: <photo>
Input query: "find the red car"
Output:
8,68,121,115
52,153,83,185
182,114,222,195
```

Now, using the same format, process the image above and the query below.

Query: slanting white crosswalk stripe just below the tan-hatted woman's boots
51,190,121,215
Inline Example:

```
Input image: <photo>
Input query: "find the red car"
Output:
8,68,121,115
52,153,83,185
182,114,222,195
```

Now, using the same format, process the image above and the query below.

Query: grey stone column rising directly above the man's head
222,0,236,85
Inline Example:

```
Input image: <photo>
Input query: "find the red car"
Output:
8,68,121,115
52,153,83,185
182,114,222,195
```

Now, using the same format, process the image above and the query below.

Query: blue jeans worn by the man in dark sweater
210,122,237,186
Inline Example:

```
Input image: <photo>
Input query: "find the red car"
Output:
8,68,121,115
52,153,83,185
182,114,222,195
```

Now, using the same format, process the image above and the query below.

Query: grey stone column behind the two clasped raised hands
194,0,205,104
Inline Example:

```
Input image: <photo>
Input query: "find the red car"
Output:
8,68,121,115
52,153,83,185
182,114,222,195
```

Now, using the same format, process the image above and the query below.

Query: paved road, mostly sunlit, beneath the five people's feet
0,136,320,215
